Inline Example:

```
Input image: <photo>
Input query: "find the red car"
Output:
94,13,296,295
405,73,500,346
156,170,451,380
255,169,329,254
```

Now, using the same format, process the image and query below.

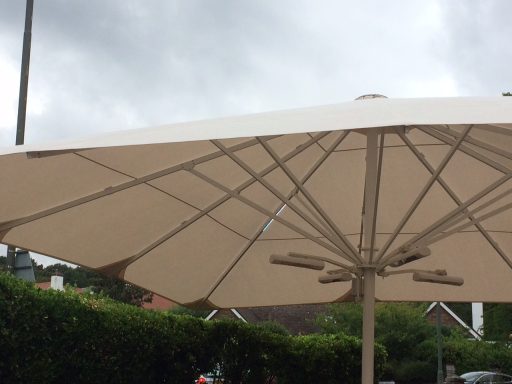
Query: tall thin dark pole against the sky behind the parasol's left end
7,0,34,273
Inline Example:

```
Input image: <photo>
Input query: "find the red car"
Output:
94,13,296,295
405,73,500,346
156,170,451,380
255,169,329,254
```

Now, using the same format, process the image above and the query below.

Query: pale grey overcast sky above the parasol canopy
0,0,512,266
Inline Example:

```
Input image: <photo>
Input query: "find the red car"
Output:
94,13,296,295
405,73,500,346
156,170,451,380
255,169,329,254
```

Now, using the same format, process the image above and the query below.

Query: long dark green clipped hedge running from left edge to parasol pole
0,273,385,384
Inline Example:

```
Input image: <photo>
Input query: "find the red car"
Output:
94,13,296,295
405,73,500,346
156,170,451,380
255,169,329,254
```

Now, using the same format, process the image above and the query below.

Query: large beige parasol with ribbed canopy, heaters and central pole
0,97,512,384
